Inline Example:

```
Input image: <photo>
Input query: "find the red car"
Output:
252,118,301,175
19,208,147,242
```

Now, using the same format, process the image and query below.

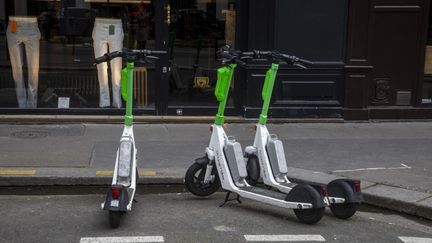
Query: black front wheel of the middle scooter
185,163,221,197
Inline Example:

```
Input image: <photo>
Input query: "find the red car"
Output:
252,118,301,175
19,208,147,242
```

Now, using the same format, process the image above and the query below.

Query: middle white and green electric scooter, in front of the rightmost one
185,46,325,224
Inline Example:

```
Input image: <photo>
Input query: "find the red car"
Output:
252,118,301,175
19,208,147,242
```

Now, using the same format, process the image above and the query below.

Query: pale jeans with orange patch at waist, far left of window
6,17,41,108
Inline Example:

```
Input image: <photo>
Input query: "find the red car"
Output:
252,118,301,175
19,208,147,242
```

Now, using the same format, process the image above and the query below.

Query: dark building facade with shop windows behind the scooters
0,0,432,120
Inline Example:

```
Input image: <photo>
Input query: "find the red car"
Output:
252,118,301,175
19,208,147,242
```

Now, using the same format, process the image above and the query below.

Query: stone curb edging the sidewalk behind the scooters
0,167,432,220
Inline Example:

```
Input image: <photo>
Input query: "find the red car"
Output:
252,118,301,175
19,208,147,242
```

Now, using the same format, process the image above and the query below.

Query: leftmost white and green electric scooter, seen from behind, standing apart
95,49,166,228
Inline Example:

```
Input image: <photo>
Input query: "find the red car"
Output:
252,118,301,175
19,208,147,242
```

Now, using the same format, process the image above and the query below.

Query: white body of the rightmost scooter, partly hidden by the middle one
245,124,345,206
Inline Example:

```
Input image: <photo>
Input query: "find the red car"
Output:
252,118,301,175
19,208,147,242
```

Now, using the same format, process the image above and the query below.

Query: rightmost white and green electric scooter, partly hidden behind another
245,51,362,219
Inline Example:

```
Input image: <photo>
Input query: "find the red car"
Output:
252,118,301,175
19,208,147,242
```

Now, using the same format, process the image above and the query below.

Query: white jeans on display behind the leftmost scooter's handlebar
92,18,124,108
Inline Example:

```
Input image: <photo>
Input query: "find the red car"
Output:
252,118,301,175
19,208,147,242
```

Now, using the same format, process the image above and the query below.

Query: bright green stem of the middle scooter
215,64,237,125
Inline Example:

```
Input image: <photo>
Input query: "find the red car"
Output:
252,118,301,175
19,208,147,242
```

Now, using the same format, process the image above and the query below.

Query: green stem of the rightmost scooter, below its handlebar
259,63,279,125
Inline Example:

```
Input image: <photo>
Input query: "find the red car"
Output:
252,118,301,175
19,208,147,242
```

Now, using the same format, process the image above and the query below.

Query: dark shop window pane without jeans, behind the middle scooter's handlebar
169,0,236,106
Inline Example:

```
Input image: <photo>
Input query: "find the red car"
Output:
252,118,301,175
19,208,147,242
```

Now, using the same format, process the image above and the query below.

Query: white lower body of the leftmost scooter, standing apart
101,126,137,211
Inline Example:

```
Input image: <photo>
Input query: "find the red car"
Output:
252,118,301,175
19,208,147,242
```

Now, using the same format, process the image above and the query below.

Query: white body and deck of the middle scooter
205,124,313,209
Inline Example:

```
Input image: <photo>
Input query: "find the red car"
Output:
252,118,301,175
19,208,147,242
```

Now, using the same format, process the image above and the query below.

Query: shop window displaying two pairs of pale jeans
0,0,155,109
